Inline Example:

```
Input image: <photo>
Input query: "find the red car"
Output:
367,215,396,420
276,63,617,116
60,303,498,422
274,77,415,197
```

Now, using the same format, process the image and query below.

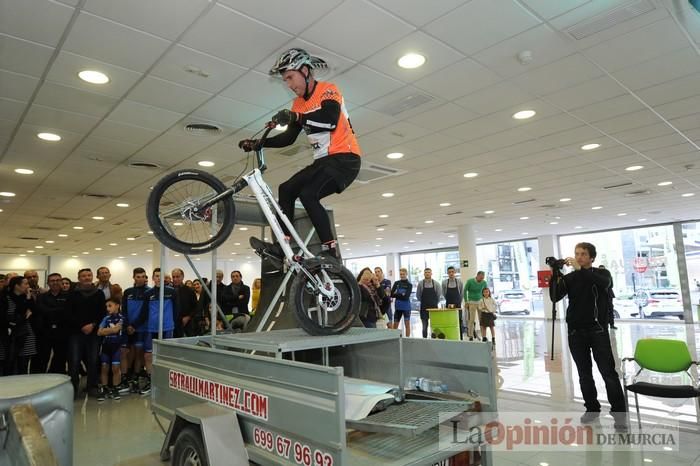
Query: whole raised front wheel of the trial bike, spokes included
146,169,236,254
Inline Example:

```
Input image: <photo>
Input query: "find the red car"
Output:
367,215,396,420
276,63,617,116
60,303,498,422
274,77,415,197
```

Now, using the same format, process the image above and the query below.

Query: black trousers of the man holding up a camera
569,327,627,412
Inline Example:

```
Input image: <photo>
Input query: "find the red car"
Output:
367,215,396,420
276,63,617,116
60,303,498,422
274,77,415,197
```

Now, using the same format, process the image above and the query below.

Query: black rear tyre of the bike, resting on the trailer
289,258,360,335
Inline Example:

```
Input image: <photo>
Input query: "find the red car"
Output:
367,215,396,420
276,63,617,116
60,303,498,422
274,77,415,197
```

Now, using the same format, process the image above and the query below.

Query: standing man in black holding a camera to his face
547,243,627,429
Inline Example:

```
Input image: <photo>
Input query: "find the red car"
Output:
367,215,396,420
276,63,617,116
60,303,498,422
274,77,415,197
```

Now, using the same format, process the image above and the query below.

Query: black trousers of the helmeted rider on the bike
279,153,360,243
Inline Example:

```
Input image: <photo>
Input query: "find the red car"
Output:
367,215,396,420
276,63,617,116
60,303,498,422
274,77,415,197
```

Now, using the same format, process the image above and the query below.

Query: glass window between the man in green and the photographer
476,240,544,317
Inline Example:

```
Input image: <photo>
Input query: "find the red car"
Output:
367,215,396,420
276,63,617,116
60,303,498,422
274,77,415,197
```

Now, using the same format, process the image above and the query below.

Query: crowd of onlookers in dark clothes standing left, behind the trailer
0,267,261,400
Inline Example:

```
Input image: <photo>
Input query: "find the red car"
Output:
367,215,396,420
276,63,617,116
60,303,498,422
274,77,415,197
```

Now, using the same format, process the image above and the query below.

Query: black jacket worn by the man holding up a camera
549,268,612,329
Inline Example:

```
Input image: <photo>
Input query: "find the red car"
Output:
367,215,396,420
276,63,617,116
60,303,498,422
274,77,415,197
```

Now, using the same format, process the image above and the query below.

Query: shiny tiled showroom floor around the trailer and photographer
74,318,700,466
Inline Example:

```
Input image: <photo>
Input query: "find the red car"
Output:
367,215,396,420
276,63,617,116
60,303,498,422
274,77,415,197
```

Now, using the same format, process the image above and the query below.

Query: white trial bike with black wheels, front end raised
146,125,360,335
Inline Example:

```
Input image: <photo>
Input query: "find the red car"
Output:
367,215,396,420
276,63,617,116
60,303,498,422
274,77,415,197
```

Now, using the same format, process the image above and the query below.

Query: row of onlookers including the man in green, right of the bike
357,266,497,344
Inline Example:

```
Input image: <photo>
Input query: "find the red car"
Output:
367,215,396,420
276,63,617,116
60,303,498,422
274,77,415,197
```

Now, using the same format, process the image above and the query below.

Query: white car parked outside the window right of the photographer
613,288,683,320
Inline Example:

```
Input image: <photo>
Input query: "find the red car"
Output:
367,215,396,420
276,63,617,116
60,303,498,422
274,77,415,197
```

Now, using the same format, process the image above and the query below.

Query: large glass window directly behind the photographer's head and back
559,225,698,319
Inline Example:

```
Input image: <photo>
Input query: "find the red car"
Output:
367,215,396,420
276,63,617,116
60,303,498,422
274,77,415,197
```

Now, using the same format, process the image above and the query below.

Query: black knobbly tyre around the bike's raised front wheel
146,169,236,255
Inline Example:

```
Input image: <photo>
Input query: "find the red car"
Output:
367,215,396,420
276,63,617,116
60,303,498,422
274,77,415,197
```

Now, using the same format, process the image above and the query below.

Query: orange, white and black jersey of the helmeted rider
292,81,360,159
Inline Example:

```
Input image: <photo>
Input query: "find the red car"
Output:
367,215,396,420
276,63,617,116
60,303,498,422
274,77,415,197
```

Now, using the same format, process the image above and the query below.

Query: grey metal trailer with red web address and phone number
152,328,497,466
